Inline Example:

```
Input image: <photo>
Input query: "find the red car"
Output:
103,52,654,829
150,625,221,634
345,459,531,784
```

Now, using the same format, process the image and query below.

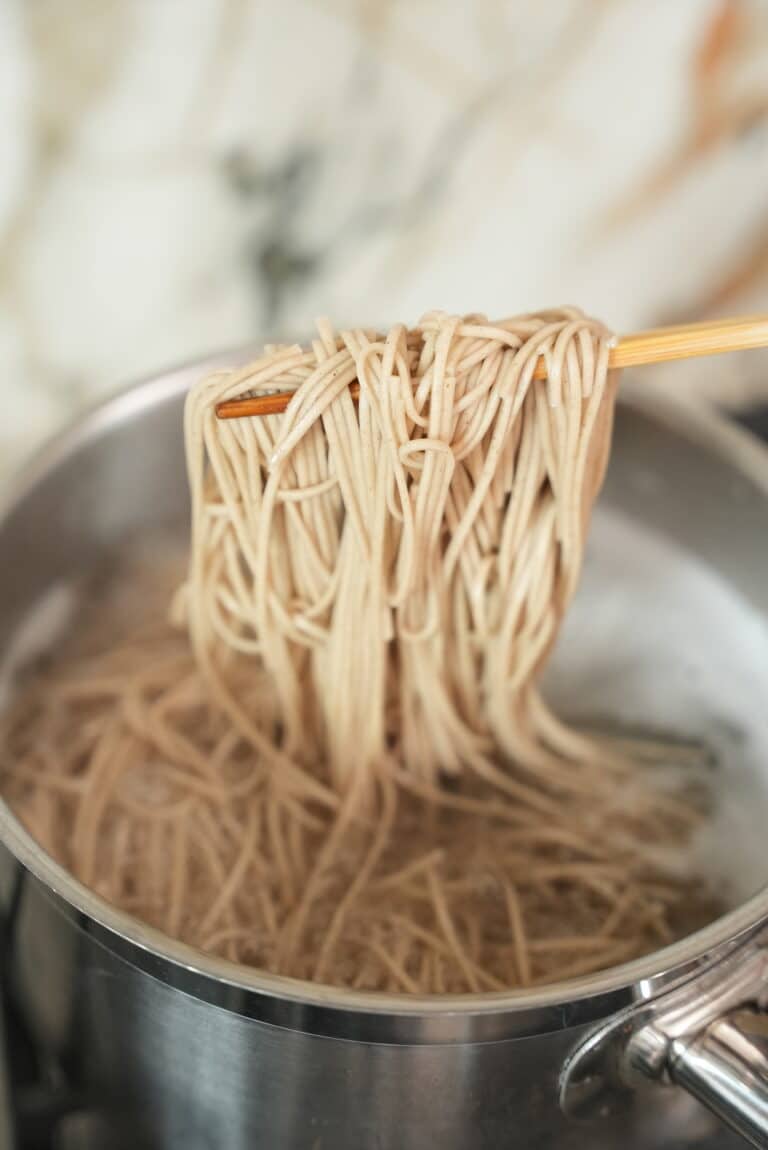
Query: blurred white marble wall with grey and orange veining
0,0,768,473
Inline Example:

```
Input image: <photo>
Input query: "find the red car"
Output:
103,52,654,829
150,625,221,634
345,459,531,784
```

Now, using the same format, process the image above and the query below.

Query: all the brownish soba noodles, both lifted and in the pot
0,309,711,994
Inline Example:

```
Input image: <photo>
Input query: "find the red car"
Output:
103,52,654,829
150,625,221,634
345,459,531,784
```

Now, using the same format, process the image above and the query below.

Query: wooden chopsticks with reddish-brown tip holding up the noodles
216,315,768,420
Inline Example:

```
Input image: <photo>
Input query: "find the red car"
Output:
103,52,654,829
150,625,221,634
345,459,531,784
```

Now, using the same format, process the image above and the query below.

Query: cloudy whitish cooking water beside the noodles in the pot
0,506,768,905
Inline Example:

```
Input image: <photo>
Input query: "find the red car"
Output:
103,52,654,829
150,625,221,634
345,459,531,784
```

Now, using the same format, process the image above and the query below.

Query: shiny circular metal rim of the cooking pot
0,347,768,1043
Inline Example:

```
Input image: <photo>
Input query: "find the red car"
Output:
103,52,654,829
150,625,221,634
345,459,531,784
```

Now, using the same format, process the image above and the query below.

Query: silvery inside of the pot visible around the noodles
0,368,768,1012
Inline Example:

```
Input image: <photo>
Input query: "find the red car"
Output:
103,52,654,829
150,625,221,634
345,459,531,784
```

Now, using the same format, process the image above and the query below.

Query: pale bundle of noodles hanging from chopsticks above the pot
181,312,614,791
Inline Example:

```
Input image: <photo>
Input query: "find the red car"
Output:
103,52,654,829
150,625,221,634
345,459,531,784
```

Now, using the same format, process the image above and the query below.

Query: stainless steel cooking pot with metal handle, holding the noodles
0,358,768,1150
